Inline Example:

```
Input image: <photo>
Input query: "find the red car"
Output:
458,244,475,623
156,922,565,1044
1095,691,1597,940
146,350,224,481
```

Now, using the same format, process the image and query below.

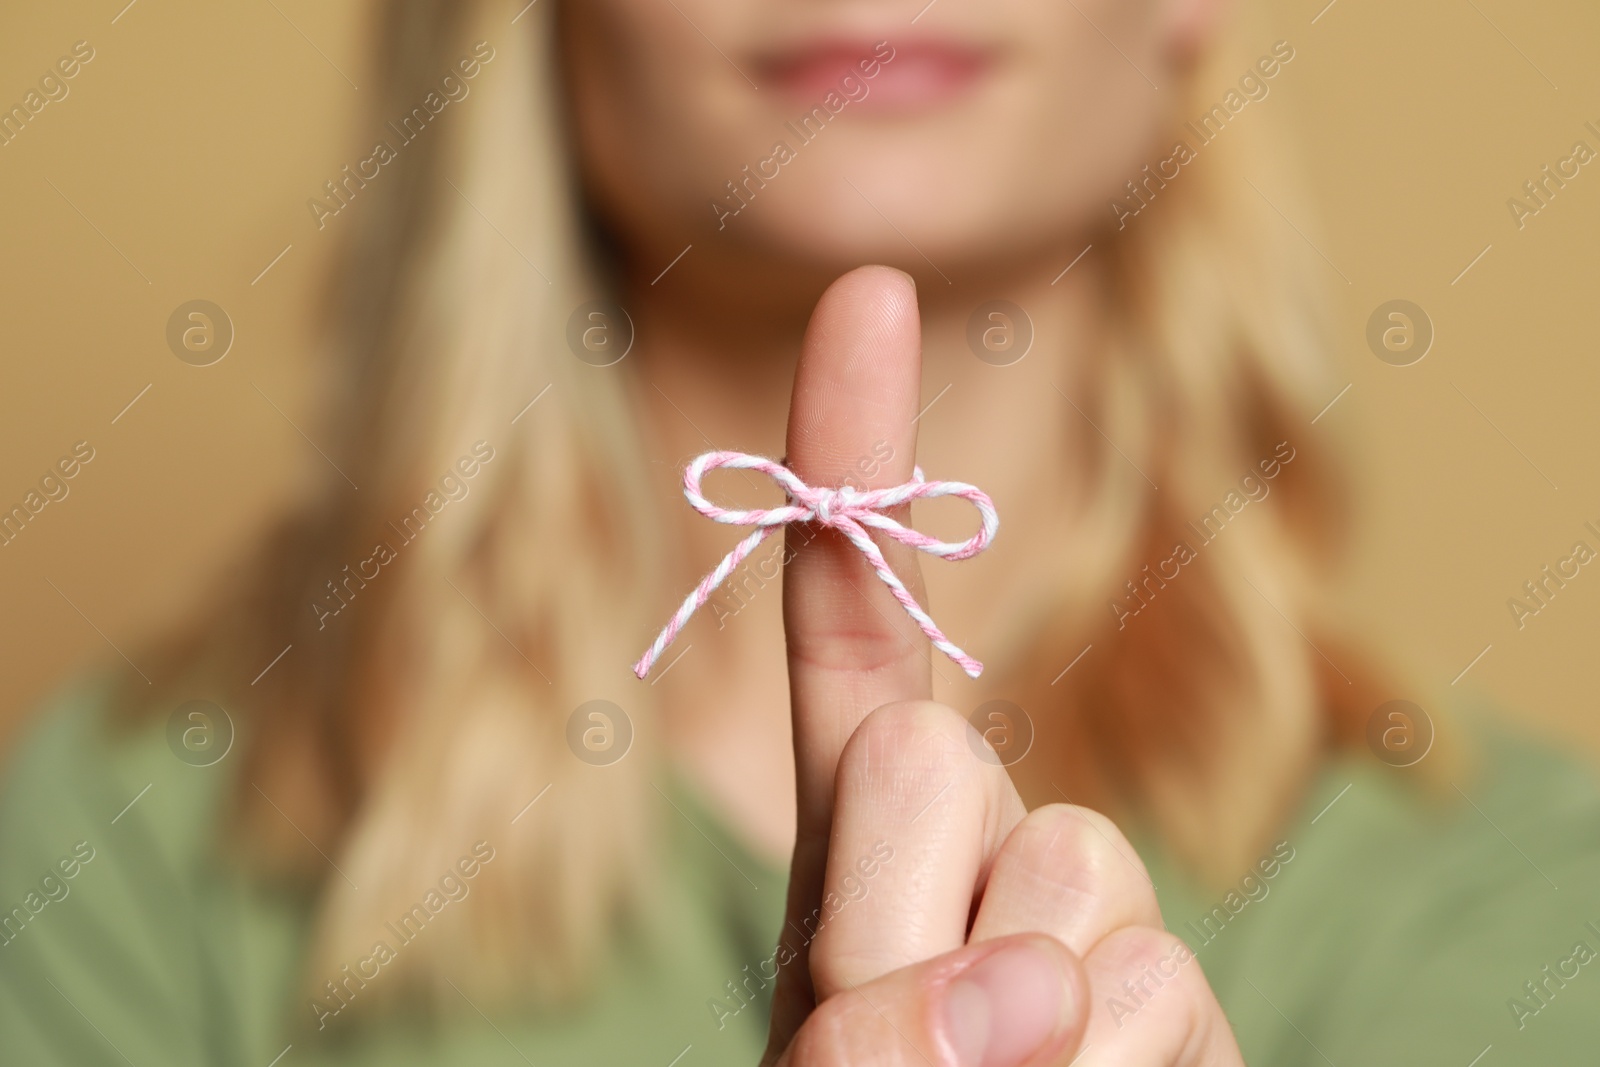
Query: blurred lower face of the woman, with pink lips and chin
562,0,1210,279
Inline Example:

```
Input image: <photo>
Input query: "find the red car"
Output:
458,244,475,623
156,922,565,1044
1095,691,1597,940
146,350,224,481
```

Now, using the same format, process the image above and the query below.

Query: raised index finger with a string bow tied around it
771,267,933,1054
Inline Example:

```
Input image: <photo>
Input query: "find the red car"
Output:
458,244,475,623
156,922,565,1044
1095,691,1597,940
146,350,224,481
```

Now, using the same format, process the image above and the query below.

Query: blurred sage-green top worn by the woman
0,685,1600,1067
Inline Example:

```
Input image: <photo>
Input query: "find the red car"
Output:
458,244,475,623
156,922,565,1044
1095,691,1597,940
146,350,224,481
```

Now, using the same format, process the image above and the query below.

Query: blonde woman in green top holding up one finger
0,0,1600,1067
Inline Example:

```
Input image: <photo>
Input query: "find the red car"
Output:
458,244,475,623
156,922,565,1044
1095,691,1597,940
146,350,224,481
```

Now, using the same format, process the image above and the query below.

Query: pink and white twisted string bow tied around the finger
634,451,1000,678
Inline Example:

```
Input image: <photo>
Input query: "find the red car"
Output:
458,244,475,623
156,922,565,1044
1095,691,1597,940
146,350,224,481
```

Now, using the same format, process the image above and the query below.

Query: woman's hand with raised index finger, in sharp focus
766,267,1242,1067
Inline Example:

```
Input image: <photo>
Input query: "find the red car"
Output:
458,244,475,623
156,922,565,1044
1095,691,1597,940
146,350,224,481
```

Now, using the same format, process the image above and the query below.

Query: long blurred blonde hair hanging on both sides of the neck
131,0,1382,1023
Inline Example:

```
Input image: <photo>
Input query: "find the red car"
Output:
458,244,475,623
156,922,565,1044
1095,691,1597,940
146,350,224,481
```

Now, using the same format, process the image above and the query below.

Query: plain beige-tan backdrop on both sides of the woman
0,0,1600,764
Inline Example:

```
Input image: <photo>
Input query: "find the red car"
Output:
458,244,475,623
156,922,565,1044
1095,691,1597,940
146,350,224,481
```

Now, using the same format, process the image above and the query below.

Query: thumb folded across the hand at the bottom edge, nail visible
778,934,1088,1067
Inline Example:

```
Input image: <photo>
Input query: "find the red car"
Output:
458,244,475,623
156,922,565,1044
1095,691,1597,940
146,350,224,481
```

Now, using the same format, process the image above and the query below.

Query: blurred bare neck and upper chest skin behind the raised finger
627,253,1098,859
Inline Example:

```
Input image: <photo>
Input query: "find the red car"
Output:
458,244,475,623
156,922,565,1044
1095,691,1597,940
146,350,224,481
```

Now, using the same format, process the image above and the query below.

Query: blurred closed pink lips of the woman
757,42,992,110
